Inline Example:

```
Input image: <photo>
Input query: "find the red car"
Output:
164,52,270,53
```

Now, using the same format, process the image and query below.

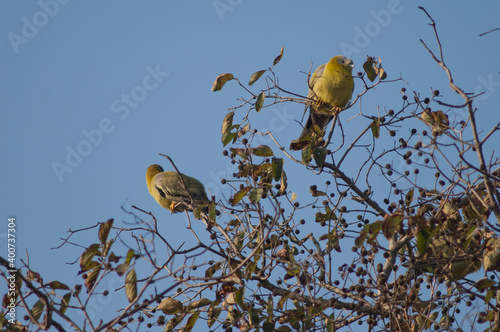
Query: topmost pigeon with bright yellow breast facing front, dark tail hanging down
290,55,354,150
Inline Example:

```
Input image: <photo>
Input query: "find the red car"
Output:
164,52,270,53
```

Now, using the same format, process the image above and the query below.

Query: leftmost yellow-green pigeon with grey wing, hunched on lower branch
146,164,209,213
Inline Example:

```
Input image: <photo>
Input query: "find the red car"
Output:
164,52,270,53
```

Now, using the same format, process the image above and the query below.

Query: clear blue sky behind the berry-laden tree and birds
0,0,500,326
